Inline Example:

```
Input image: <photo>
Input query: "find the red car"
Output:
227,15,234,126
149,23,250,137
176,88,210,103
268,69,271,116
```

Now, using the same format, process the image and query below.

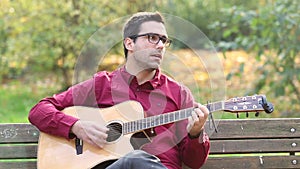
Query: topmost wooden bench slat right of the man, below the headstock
206,118,300,140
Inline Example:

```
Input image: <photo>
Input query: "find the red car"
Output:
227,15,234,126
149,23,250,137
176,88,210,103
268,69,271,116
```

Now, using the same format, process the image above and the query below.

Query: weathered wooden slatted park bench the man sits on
0,118,300,169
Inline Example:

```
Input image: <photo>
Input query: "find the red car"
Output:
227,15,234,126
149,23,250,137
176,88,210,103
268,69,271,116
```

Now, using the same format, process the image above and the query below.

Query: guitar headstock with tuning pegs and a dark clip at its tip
224,95,274,113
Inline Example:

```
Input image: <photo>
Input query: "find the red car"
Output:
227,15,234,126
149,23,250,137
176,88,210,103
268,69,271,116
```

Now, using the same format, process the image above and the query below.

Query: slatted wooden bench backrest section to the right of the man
202,118,300,169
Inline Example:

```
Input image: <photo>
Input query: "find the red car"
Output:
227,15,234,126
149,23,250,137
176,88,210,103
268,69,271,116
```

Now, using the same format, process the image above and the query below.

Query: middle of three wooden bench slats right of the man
210,139,300,154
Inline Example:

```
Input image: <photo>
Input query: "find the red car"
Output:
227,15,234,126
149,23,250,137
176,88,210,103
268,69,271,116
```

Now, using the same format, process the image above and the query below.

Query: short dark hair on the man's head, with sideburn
123,12,165,58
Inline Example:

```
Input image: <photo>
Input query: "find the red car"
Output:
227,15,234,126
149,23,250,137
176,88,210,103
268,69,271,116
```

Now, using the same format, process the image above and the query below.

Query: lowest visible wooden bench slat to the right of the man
201,156,300,169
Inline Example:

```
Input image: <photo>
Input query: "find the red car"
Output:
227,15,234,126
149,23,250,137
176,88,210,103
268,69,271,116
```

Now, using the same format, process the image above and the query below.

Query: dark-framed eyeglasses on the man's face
129,33,172,47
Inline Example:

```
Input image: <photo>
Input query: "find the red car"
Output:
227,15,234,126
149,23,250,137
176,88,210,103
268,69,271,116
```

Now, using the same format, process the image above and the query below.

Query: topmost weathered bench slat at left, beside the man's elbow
0,123,39,144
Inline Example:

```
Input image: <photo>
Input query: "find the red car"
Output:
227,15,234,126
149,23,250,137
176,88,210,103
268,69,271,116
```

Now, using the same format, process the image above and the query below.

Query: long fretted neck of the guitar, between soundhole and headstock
123,101,224,134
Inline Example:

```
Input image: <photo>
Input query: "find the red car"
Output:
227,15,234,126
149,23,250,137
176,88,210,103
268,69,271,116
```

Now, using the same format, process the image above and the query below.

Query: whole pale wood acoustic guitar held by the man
37,95,273,169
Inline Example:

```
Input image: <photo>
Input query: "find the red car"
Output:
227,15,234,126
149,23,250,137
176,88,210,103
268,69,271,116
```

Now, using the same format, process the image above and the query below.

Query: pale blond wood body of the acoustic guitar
37,101,144,169
